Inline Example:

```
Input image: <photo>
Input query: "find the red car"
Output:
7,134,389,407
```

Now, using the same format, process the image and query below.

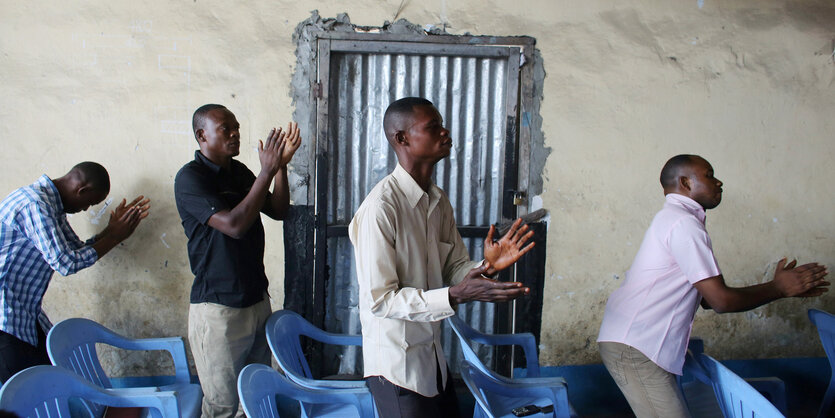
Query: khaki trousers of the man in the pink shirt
597,342,690,418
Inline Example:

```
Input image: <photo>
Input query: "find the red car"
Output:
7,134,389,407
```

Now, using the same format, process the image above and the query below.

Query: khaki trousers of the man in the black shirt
188,298,272,418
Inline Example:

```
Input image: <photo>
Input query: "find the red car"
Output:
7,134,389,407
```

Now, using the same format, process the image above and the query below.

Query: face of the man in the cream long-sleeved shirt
404,106,452,163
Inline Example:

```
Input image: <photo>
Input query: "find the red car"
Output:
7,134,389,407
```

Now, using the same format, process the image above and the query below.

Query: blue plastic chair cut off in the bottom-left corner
0,366,179,418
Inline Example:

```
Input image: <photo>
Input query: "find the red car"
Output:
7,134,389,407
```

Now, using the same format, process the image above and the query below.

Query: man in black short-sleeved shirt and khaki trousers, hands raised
174,104,301,418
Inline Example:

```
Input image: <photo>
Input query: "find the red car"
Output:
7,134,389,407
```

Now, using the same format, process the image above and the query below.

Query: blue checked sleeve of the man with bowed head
17,202,98,276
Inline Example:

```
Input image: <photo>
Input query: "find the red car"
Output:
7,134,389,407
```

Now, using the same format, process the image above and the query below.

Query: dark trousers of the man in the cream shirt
365,366,461,418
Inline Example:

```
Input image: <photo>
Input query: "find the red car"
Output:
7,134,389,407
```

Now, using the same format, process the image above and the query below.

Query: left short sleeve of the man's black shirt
174,169,231,225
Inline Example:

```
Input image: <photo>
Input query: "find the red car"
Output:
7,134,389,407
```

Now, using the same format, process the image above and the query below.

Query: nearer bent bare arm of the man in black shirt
208,128,287,239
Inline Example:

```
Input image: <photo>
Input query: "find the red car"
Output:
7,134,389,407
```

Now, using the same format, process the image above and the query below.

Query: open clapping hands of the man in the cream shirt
449,219,534,304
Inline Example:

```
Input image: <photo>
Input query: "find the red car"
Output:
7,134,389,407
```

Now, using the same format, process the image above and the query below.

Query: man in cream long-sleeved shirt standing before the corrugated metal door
349,97,533,417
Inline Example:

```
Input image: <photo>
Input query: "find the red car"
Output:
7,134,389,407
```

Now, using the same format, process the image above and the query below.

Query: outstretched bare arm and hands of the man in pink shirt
694,259,829,313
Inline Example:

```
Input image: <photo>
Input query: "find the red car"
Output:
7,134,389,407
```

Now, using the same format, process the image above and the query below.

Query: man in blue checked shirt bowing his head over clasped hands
0,162,150,382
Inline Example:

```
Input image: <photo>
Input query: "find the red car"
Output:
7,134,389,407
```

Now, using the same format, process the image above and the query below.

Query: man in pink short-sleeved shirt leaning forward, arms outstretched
597,155,829,417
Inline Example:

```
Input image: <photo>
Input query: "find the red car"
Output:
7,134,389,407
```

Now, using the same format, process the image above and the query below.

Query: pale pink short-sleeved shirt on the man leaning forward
597,193,722,375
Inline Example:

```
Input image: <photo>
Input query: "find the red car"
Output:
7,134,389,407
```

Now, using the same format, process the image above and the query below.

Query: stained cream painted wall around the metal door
0,0,835,375
